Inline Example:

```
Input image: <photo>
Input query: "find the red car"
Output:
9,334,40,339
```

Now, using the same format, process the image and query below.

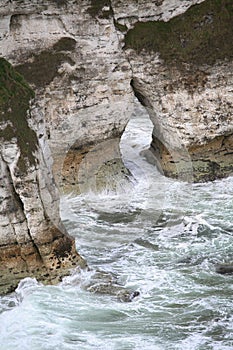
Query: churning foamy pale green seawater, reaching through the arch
0,105,233,350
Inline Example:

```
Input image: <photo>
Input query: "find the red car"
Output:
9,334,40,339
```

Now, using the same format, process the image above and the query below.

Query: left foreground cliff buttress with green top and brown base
0,58,84,293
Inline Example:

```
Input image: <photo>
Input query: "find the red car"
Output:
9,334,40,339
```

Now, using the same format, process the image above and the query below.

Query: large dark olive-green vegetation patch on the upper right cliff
125,0,233,65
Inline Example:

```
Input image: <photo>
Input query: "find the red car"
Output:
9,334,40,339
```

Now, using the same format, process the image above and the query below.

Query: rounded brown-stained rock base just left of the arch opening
57,137,131,194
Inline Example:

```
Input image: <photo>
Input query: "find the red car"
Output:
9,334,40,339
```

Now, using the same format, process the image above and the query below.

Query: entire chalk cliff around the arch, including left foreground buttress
0,0,233,290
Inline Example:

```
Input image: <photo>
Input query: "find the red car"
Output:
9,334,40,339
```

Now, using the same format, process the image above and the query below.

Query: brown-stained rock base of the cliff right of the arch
151,135,233,182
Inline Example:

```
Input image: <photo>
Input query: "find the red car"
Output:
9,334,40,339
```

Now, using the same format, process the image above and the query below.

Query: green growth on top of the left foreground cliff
0,58,38,173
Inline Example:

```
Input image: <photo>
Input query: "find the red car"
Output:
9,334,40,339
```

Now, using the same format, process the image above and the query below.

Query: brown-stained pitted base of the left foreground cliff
0,232,86,294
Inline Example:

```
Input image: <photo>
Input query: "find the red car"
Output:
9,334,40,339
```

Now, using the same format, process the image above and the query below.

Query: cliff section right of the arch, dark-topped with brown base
125,0,233,181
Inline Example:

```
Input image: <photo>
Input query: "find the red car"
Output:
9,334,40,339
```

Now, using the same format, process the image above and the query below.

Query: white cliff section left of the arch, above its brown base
0,0,134,190
